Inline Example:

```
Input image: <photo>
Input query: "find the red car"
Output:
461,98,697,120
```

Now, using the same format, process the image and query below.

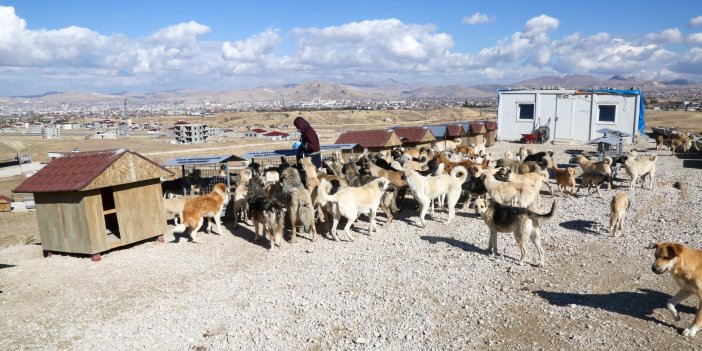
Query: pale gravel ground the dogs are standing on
0,139,702,350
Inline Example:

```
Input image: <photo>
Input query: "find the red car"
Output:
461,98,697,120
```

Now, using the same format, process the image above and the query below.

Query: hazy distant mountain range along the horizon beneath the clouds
0,74,702,104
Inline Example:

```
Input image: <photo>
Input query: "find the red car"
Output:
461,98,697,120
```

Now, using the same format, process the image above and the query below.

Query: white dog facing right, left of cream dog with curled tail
319,177,395,241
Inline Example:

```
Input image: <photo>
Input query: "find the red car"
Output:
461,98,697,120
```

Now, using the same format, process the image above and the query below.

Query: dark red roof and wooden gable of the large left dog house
13,149,173,193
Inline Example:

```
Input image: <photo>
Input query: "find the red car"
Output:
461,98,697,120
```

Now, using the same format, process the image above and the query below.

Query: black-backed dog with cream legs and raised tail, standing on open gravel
475,199,556,267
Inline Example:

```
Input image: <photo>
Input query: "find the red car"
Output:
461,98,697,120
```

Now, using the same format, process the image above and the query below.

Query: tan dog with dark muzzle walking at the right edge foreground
648,242,702,337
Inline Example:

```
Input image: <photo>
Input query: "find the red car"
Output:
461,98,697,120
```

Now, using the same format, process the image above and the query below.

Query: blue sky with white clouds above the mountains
0,0,702,96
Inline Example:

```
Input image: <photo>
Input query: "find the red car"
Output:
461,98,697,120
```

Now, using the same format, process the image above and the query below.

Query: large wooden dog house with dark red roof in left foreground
13,149,173,261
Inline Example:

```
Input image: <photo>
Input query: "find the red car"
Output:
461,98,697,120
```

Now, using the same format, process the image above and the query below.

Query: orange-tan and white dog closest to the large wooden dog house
172,183,229,243
